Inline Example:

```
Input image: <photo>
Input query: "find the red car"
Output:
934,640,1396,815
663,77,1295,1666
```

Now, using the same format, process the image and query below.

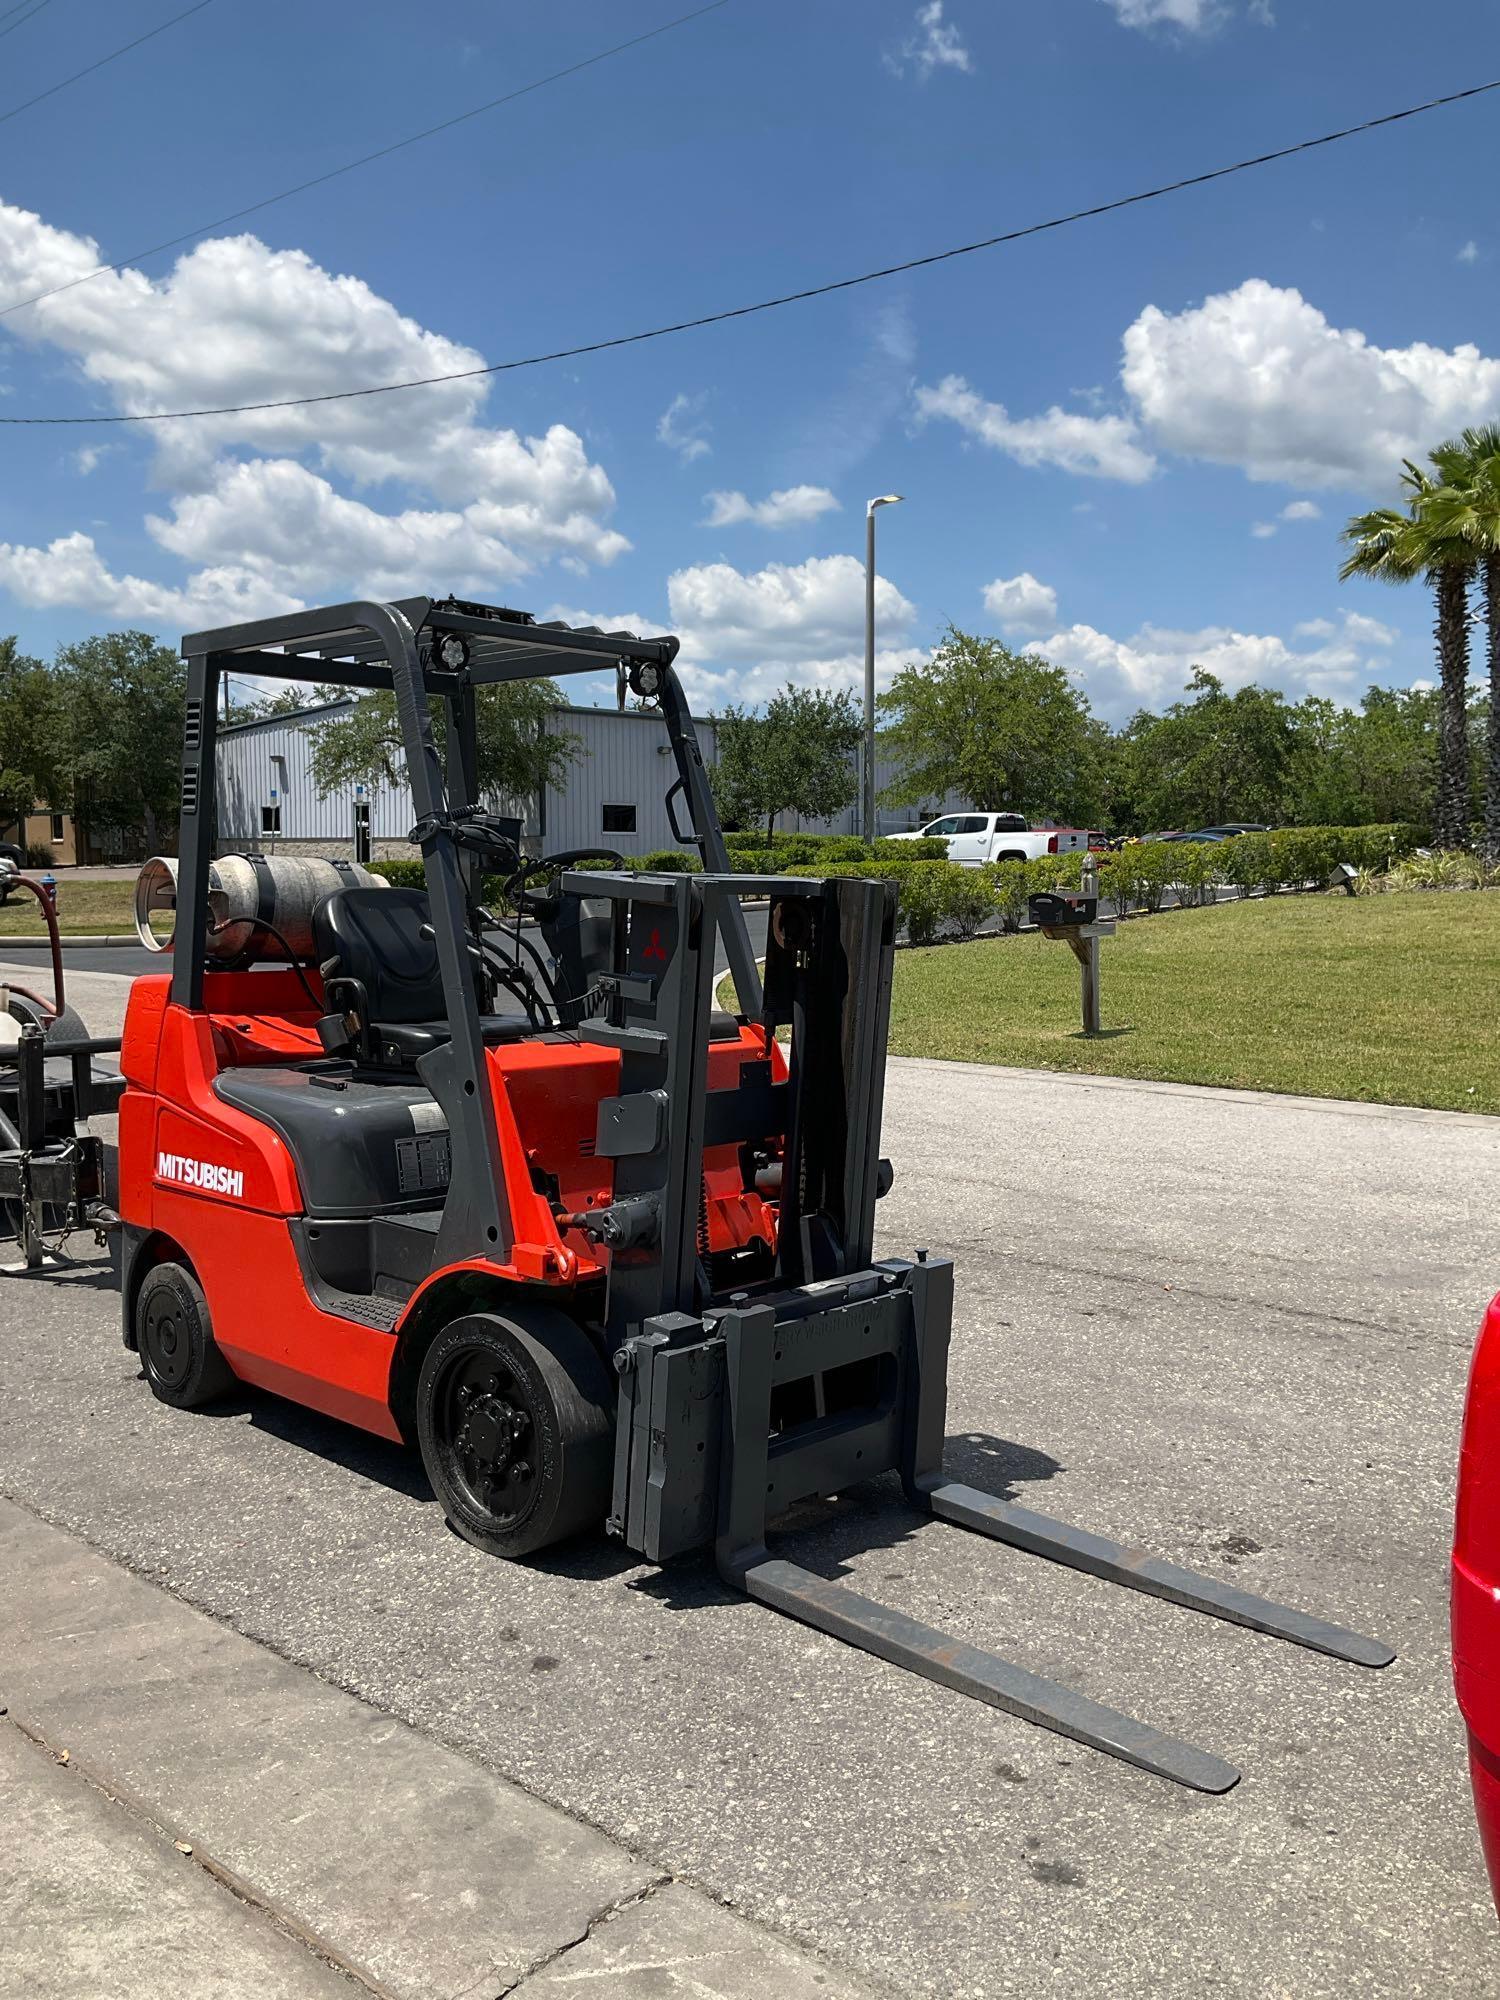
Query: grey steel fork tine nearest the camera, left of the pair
742,1558,1240,1792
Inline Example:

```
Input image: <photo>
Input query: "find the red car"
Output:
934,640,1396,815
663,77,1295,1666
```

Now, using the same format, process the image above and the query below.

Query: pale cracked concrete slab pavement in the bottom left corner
0,1502,868,2000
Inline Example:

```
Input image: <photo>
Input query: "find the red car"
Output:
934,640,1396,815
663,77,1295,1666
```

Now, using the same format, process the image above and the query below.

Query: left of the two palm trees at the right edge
1338,450,1476,848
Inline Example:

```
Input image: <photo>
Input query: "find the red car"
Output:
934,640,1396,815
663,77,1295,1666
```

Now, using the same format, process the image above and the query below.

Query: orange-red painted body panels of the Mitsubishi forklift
120,972,786,1438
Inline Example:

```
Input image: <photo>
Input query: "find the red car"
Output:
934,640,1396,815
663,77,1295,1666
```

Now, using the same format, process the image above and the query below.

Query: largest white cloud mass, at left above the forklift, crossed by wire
0,204,630,624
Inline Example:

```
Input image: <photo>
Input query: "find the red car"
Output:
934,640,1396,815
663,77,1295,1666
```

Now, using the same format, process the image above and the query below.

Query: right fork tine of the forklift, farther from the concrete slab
926,1482,1396,1666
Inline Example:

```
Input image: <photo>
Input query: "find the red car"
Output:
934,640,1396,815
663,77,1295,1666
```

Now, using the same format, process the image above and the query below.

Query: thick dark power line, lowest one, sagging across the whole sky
0,78,1500,426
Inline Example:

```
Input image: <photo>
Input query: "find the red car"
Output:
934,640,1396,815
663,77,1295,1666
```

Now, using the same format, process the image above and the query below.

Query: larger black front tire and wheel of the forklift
416,1304,616,1560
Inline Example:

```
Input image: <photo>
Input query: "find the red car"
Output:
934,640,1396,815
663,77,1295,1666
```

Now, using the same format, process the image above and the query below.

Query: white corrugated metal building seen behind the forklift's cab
218,696,962,854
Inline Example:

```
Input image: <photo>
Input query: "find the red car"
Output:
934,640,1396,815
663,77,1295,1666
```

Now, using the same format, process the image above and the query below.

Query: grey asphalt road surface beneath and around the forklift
0,960,1500,2000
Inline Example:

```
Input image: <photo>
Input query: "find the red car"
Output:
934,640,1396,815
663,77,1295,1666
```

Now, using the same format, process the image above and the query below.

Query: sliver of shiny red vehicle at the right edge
1452,1298,1500,1900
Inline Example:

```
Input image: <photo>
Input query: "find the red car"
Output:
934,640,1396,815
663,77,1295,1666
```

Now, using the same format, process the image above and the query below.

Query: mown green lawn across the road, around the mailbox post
890,892,1500,1112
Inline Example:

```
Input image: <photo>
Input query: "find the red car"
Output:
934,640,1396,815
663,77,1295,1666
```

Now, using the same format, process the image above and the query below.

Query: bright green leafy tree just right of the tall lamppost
880,626,1106,824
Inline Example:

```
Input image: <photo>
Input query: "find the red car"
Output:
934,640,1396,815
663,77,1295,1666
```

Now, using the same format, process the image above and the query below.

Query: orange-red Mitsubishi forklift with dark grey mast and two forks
108,598,1392,1792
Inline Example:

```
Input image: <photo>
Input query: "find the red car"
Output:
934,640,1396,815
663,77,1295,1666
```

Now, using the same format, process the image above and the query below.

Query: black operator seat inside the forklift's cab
312,888,452,1068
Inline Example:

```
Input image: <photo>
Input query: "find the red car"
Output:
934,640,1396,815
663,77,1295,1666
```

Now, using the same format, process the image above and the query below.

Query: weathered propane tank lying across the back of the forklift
136,854,390,964
